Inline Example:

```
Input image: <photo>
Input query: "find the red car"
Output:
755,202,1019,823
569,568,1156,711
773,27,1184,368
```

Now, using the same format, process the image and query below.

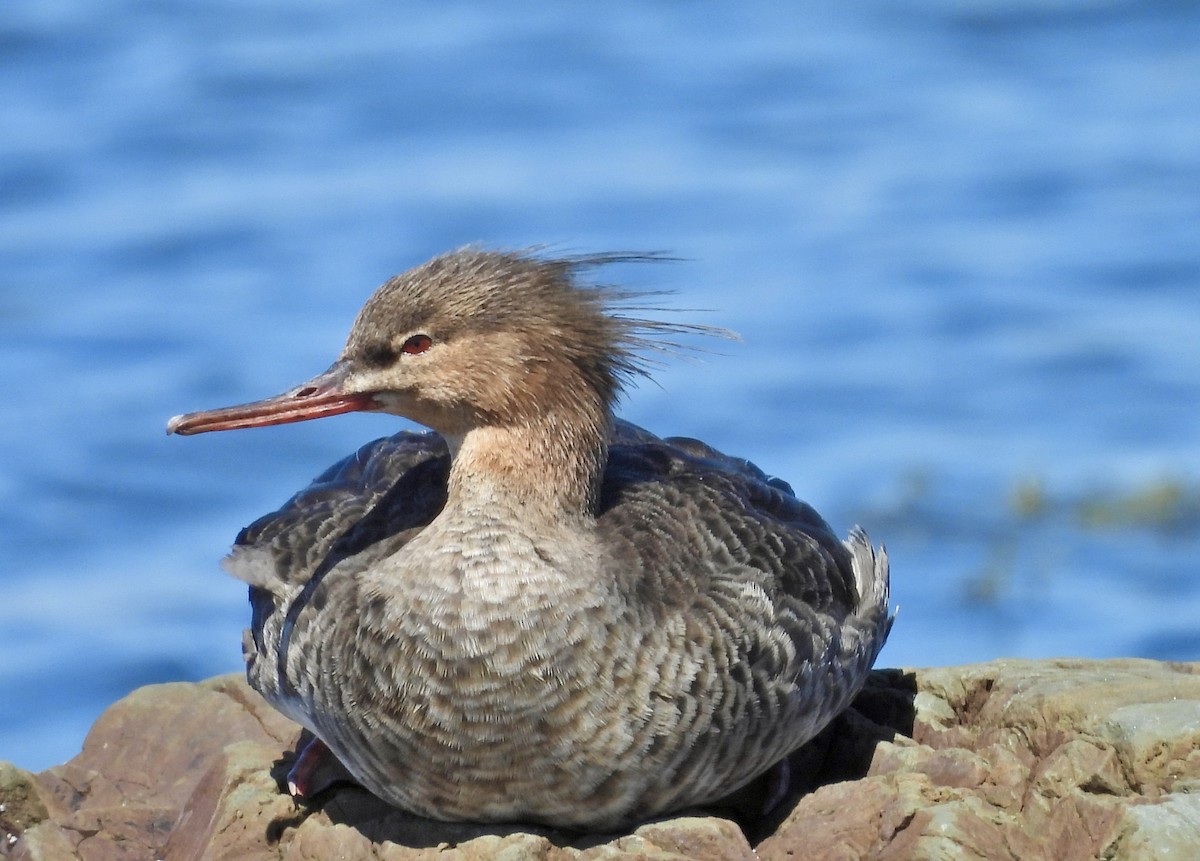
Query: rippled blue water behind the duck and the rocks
0,0,1200,769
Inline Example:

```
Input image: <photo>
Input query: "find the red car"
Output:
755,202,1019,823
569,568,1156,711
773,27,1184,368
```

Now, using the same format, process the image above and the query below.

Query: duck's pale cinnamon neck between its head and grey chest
446,409,611,520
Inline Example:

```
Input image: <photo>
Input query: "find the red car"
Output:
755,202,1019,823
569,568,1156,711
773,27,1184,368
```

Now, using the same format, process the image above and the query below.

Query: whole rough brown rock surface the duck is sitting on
0,660,1200,861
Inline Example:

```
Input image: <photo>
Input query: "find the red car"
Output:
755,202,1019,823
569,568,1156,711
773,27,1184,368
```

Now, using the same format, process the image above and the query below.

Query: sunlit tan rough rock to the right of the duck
757,660,1200,861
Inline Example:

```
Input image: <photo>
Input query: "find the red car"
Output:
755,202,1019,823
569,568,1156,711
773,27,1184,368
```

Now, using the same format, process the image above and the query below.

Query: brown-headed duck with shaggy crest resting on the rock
167,246,893,831
